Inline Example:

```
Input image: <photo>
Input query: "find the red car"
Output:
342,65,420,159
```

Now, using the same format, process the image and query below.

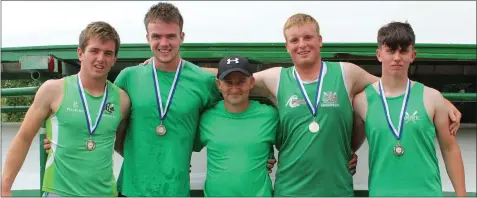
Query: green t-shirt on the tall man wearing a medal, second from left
115,61,220,196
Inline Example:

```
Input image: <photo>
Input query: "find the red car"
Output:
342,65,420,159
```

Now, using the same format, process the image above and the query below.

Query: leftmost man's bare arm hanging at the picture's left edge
2,80,58,196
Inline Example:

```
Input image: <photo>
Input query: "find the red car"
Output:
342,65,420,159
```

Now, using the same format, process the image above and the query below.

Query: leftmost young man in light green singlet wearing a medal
2,22,130,196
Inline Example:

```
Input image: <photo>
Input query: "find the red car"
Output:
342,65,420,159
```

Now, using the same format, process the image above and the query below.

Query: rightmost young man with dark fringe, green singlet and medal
353,22,466,196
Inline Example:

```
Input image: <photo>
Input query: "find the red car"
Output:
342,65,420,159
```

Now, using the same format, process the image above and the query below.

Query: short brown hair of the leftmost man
79,21,121,55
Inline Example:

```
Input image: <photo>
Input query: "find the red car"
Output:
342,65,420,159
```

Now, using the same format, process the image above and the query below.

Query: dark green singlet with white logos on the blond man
275,62,353,196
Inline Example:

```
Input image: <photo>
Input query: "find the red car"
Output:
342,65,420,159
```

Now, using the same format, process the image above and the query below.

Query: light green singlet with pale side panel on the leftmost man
42,75,121,196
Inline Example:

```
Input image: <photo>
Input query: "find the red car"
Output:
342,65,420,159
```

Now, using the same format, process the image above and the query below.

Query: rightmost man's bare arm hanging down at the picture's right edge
432,88,466,196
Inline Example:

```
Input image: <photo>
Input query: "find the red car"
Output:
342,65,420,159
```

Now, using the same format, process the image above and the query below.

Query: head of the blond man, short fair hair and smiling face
283,14,323,67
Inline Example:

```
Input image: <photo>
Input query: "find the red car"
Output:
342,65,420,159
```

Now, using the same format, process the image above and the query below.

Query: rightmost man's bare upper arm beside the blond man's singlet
351,91,368,152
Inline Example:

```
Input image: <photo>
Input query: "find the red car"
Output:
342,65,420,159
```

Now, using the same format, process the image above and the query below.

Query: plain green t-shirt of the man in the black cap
199,100,278,197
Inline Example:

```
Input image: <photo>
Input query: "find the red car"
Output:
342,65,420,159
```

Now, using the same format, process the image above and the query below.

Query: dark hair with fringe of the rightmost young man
378,21,416,50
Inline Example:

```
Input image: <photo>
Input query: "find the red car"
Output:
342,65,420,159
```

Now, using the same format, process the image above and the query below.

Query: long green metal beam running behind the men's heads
2,43,477,63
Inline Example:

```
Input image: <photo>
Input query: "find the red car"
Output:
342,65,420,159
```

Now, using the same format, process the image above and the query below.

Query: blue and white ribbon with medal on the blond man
293,64,325,133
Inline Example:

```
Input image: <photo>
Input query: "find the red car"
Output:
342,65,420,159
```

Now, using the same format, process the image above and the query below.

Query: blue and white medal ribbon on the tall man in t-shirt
152,59,182,122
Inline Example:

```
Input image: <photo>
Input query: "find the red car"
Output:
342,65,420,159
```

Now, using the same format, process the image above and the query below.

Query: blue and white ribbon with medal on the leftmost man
76,74,108,151
